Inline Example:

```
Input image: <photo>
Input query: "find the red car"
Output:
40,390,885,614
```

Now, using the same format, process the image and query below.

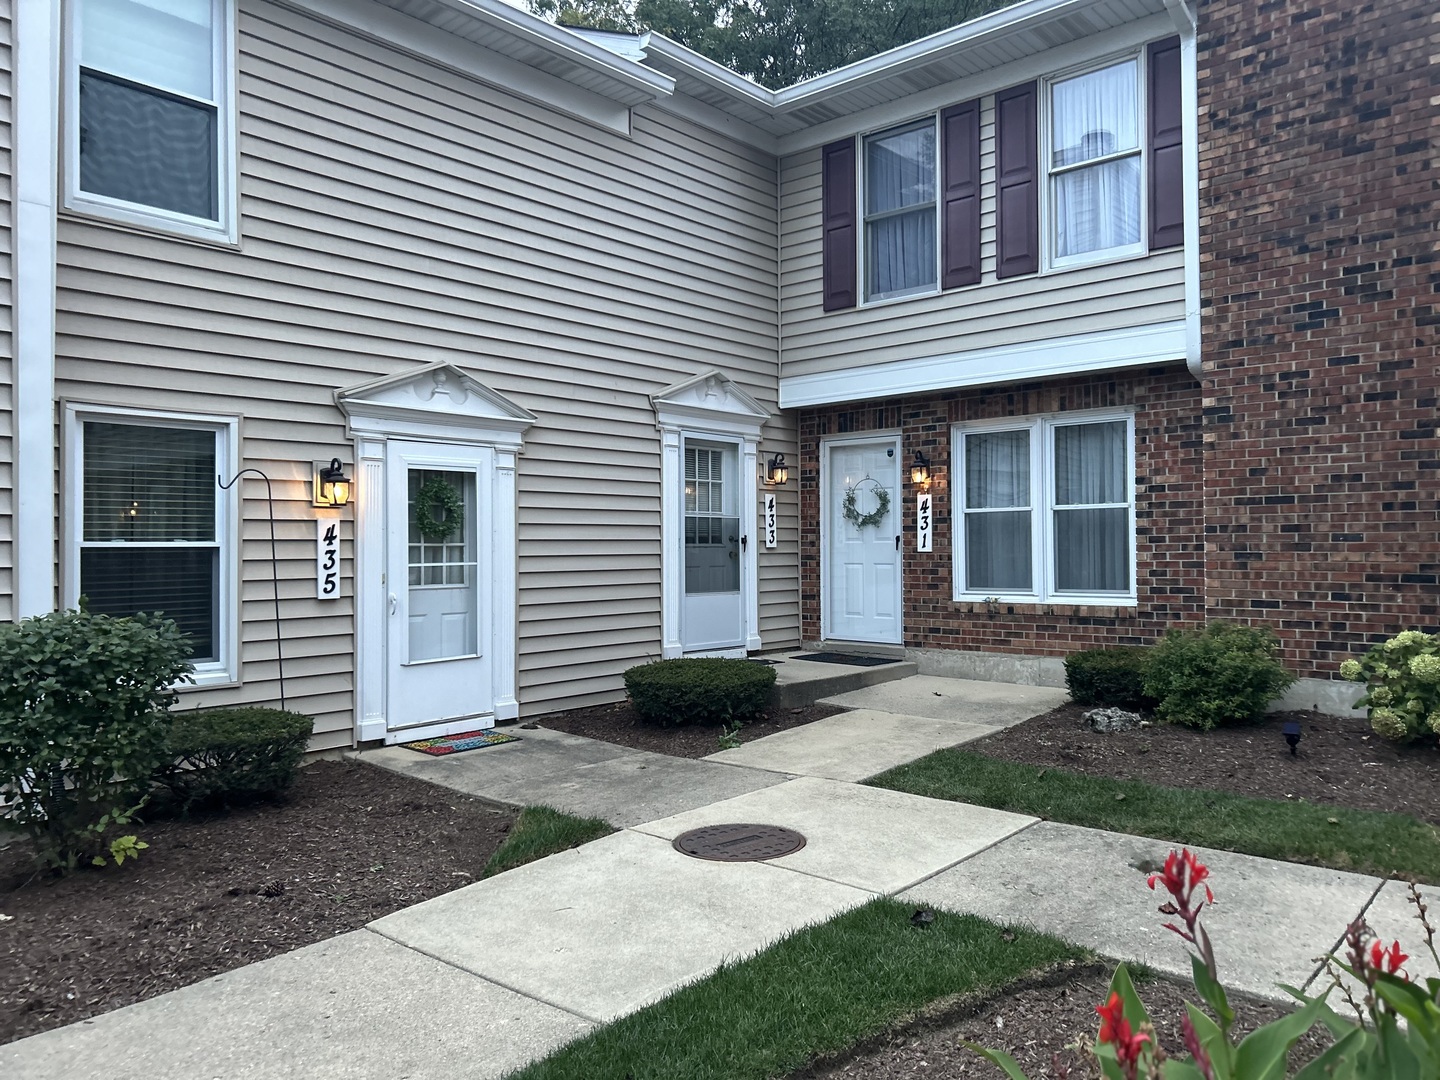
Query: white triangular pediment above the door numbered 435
336,360,536,442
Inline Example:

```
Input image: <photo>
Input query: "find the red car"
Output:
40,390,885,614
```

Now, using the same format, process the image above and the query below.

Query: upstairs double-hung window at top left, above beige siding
65,0,235,239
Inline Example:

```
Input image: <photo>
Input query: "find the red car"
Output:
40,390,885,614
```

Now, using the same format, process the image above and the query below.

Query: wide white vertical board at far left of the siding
10,0,60,618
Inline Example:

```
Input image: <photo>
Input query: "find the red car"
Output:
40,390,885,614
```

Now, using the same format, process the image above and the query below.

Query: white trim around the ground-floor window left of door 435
60,403,240,690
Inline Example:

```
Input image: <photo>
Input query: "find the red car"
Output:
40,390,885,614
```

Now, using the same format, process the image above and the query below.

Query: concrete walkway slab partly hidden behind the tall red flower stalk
901,822,1381,1001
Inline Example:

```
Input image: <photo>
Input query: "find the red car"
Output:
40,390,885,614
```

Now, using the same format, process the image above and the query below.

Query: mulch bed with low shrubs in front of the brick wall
963,704,1440,824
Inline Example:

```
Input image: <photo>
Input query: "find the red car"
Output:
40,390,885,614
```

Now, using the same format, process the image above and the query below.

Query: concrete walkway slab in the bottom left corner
0,930,593,1080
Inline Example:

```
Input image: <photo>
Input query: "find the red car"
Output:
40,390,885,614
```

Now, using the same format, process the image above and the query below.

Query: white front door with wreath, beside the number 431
822,435,904,645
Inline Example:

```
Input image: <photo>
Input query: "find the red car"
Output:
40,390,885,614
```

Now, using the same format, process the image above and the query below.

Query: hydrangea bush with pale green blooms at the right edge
1341,631,1440,743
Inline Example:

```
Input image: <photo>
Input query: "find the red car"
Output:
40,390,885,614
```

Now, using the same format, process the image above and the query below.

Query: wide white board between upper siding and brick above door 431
780,320,1185,409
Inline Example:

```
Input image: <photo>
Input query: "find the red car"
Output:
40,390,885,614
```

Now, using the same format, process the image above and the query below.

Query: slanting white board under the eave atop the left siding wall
279,0,668,137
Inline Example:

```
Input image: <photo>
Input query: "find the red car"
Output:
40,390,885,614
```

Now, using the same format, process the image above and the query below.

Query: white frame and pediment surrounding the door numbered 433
651,372,770,660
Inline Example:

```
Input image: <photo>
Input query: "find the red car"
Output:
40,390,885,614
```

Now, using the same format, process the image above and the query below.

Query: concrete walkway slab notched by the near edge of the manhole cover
372,831,871,1021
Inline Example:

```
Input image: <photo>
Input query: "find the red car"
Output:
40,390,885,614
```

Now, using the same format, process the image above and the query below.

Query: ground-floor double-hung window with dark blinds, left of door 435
66,406,235,681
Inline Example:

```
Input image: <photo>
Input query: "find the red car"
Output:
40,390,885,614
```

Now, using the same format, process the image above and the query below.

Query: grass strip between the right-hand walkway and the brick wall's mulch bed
865,750,1440,883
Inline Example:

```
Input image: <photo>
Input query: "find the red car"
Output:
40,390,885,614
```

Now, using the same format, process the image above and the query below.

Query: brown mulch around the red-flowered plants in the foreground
792,966,1329,1080
